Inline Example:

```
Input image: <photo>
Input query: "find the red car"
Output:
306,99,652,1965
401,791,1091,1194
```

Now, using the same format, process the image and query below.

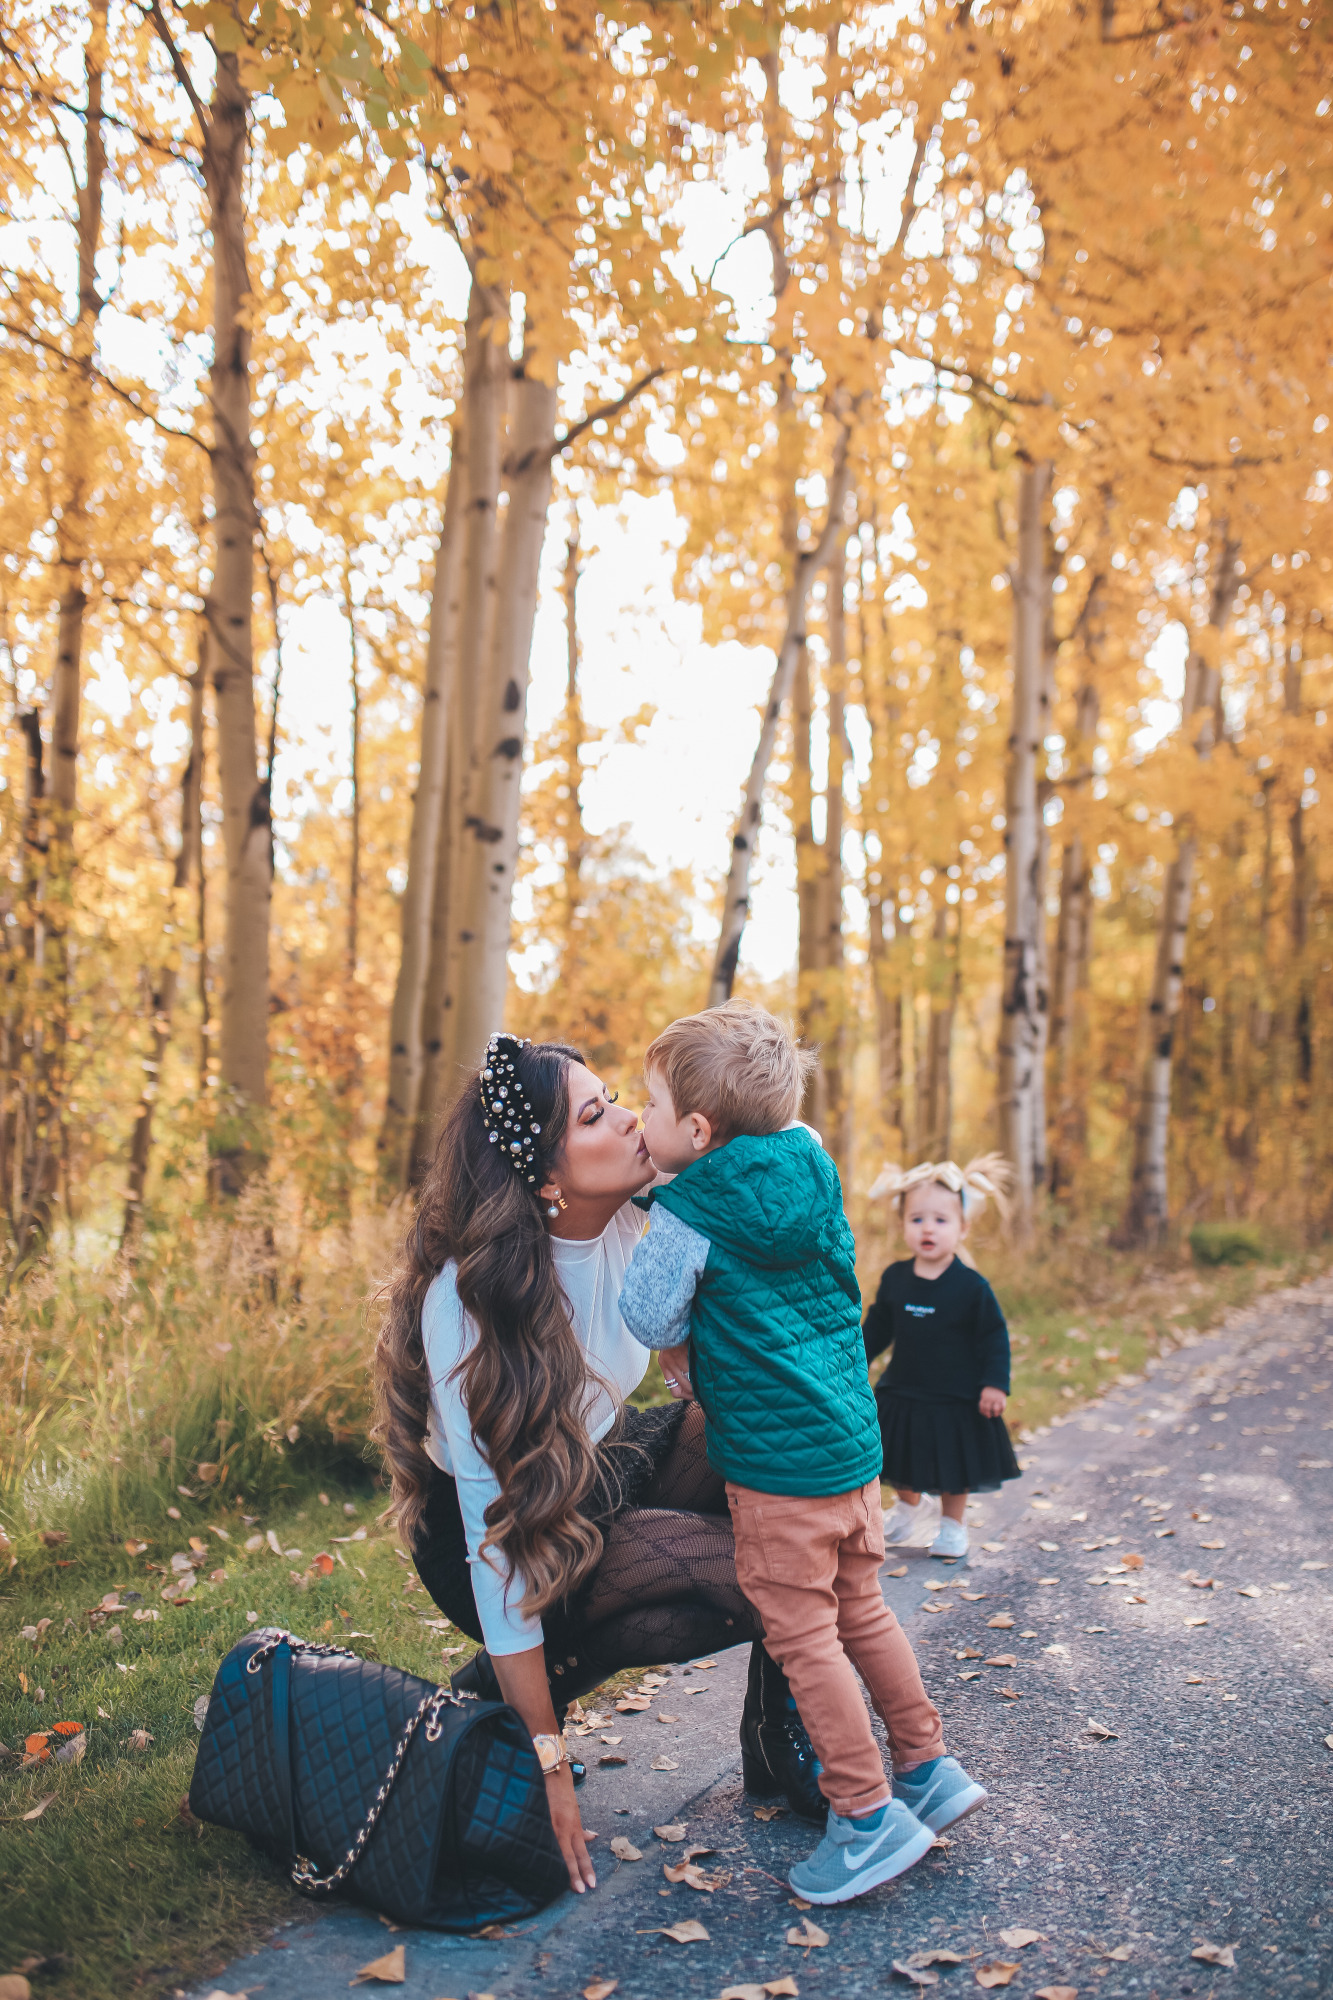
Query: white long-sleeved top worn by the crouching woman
420,1202,650,1658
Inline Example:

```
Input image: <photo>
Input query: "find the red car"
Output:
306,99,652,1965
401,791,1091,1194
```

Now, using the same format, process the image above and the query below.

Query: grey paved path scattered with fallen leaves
196,1284,1333,2000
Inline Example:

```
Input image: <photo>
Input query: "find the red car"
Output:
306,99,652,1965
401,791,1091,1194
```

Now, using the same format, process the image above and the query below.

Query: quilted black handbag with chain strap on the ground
190,1630,568,1930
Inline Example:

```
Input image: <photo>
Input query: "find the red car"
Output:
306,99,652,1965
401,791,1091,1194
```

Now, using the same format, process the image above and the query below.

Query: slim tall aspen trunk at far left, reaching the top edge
16,11,106,1262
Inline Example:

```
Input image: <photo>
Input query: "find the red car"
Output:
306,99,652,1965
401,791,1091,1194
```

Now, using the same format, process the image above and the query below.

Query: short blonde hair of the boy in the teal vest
642,1000,817,1138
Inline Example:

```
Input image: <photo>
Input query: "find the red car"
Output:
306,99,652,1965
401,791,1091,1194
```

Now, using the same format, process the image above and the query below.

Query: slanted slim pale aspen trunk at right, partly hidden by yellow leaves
1119,540,1241,1244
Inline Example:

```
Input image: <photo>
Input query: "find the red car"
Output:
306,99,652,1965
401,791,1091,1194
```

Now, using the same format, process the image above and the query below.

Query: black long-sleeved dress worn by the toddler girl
865,1256,1019,1494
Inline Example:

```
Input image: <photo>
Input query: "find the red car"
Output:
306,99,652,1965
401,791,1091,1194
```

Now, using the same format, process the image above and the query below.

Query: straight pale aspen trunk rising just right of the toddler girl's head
999,462,1051,1234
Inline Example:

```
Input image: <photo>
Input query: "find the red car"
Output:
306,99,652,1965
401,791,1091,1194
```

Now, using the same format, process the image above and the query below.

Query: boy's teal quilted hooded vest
640,1128,883,1494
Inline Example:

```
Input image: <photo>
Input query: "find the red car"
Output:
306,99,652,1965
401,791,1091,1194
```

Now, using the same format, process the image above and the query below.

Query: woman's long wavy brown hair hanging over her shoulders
372,1042,602,1616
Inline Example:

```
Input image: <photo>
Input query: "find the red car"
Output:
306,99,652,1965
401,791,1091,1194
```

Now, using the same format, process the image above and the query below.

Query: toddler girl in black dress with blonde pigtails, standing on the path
865,1152,1019,1558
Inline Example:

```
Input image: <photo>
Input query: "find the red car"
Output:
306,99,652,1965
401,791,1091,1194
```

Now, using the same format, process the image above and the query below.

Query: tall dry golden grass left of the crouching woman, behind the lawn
0,1188,400,1542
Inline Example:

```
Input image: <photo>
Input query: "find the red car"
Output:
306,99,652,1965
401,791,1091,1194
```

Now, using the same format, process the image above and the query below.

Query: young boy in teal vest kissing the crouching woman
620,1000,987,1904
